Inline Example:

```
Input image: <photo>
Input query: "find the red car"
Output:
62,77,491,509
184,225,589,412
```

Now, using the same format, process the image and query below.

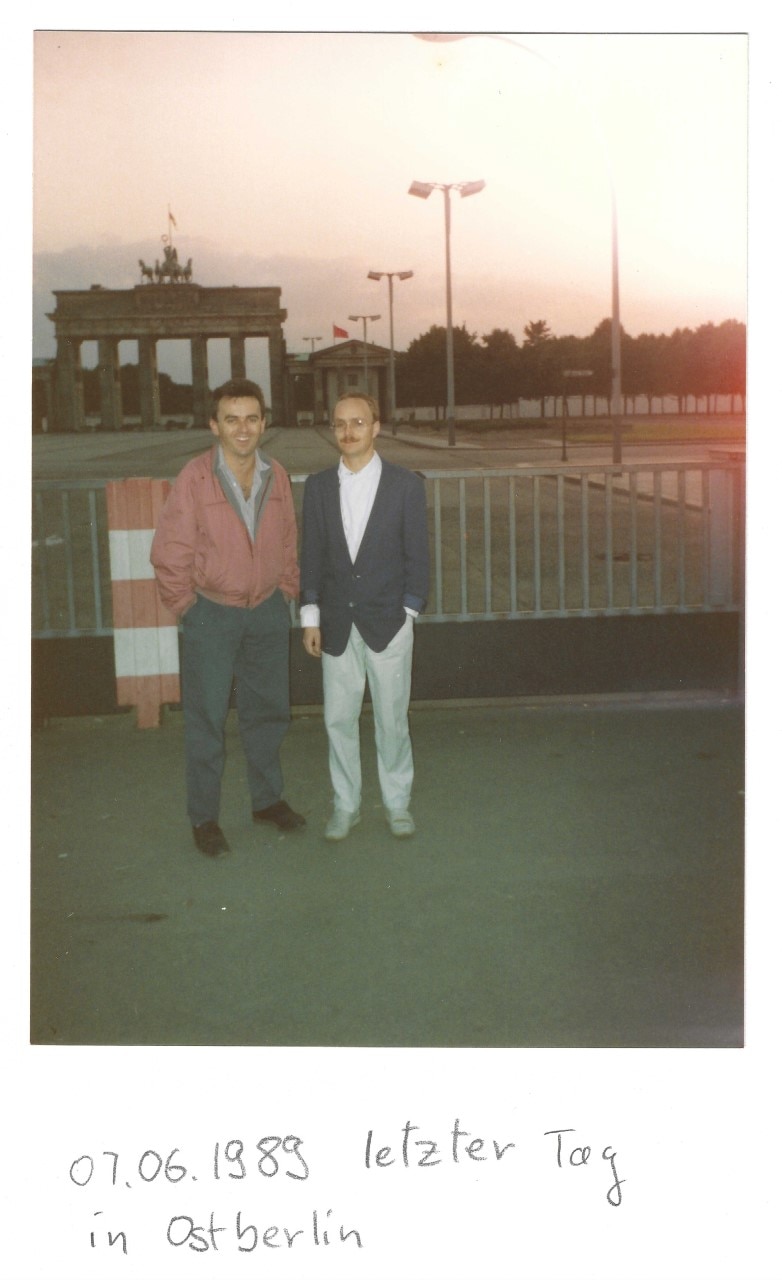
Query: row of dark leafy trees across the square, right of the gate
395,320,746,417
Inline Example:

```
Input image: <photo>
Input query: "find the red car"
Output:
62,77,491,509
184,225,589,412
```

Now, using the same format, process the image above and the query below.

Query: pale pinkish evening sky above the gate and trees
33,29,747,378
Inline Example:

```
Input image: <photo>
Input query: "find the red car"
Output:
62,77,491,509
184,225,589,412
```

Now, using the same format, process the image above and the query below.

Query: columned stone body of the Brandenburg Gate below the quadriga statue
49,277,287,431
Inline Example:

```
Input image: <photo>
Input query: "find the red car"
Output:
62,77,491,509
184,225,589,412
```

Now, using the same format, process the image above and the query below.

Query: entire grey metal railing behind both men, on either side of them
32,460,744,639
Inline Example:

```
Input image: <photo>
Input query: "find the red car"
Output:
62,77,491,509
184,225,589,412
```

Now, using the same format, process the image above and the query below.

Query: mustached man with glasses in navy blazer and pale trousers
301,394,429,840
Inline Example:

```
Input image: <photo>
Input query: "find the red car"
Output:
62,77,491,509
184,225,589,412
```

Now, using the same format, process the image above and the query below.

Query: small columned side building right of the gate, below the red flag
285,338,390,426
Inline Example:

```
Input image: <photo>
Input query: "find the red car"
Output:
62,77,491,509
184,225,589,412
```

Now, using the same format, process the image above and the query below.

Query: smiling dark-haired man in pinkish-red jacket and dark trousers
150,379,305,858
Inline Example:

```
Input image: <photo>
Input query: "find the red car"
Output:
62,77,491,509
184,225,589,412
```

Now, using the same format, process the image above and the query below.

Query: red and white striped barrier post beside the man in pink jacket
106,479,179,728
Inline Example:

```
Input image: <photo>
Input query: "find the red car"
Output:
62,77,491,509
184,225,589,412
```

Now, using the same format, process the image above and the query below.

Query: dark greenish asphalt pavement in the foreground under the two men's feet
31,699,744,1048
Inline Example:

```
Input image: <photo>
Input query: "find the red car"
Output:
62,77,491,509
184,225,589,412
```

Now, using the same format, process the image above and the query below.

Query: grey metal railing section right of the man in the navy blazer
409,462,744,622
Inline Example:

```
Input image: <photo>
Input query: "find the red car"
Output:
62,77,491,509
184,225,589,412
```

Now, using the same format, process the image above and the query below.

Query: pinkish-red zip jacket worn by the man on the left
150,445,299,616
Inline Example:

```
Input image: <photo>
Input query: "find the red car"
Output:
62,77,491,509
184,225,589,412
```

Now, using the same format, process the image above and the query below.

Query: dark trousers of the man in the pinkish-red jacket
182,590,291,827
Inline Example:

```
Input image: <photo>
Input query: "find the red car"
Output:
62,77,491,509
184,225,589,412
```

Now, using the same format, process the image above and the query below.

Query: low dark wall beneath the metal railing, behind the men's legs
32,613,741,723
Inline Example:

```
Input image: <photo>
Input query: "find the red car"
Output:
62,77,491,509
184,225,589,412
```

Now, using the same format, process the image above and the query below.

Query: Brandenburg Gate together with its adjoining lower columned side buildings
39,257,401,431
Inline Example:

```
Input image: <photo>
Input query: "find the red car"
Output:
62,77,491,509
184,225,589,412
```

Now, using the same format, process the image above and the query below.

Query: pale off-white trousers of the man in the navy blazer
323,614,413,813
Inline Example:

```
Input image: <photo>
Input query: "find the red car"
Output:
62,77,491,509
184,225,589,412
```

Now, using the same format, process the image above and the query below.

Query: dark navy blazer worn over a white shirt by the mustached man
301,462,429,657
